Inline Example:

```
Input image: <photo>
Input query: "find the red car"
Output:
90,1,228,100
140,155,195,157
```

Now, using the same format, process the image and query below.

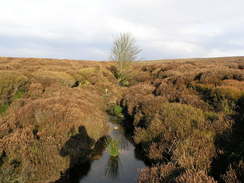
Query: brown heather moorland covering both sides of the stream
0,57,244,183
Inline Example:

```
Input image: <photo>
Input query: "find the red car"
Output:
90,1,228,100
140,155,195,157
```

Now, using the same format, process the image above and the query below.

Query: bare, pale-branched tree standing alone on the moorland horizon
111,33,141,77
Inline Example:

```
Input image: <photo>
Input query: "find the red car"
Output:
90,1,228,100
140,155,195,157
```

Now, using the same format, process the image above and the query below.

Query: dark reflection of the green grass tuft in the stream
105,156,121,179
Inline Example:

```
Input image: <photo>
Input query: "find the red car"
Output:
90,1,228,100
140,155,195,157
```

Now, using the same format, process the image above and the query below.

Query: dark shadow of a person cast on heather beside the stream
52,126,106,183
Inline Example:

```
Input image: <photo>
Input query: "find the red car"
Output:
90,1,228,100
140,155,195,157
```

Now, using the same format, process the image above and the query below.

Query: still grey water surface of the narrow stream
79,123,145,183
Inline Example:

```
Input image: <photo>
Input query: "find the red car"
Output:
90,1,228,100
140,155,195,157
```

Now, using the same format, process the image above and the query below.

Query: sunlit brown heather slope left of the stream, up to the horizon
0,58,119,182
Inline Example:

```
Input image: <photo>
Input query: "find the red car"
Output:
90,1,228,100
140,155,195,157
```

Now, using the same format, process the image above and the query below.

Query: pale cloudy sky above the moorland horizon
0,0,244,60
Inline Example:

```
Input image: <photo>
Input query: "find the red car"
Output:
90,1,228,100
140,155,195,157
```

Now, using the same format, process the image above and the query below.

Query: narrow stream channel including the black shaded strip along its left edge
59,120,146,183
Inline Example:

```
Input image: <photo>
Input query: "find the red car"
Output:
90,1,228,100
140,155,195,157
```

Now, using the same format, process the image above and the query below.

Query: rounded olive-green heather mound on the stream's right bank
134,103,205,143
